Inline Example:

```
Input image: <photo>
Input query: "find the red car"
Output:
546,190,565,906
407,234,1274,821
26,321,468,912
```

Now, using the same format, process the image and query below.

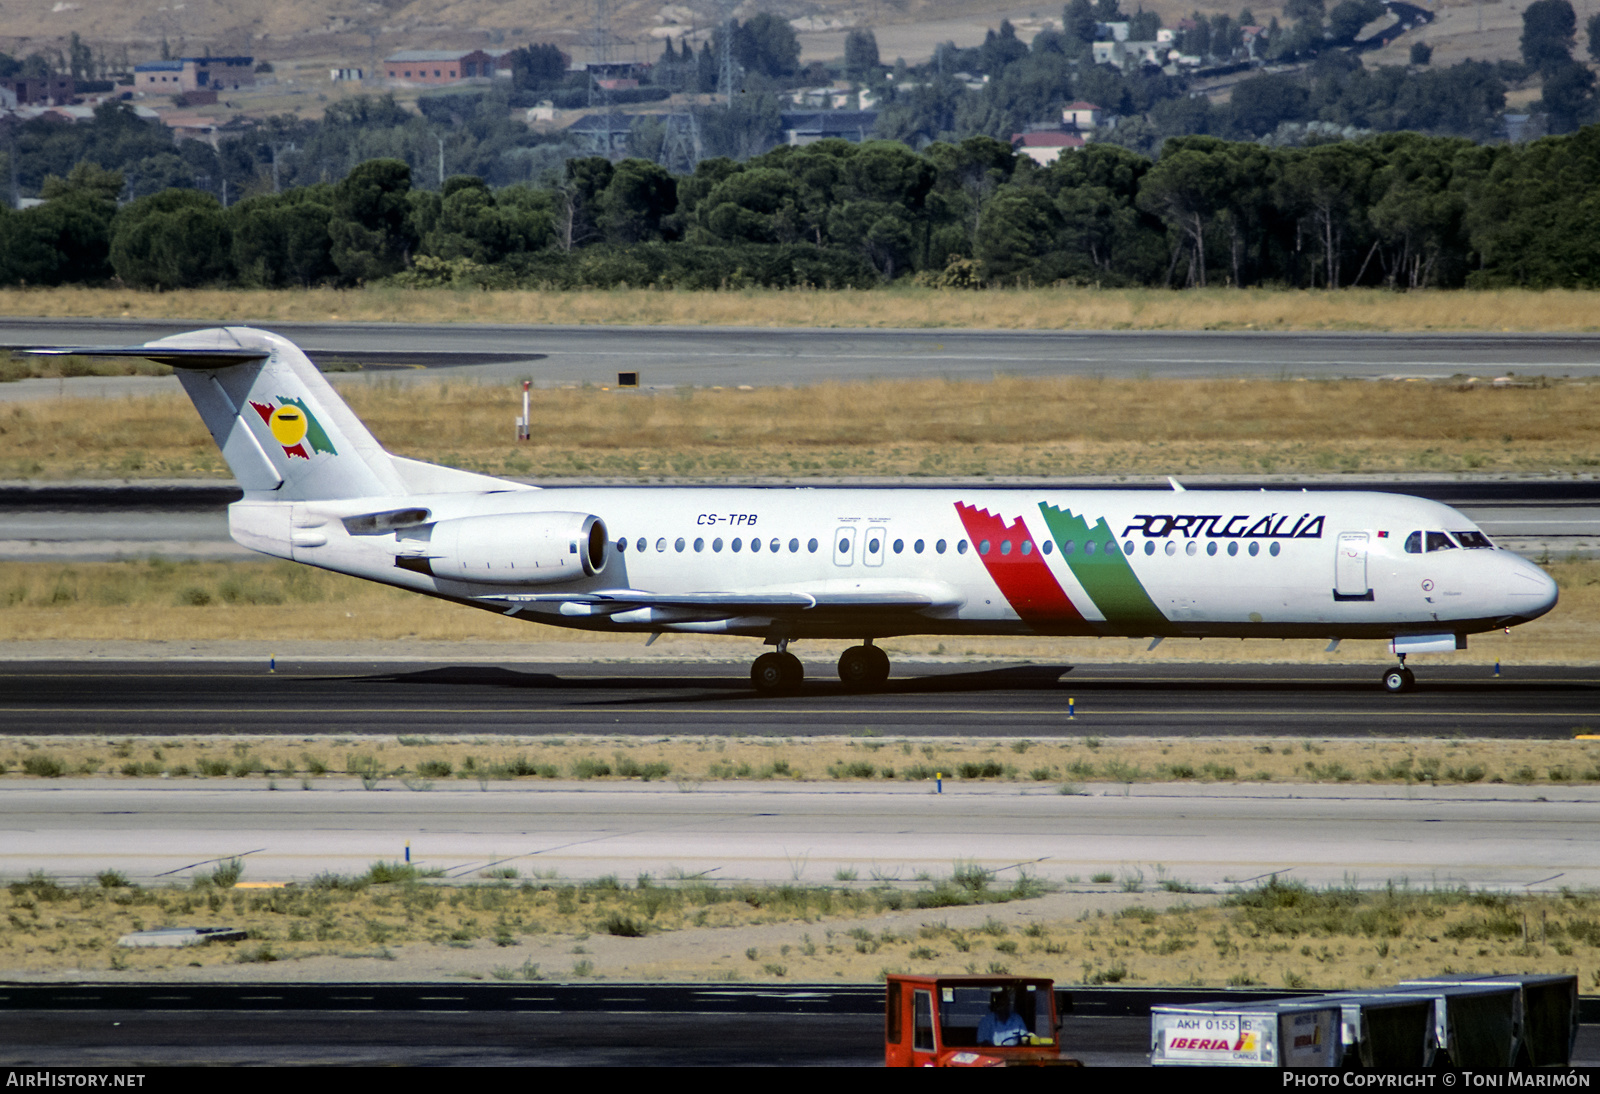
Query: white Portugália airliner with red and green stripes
40,326,1555,693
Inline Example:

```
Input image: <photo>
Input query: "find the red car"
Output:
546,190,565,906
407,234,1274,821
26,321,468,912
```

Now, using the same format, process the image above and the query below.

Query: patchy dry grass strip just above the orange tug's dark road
9,864,1600,990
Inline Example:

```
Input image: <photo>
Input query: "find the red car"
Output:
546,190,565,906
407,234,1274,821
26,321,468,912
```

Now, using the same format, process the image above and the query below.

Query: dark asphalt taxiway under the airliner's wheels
0,658,1600,739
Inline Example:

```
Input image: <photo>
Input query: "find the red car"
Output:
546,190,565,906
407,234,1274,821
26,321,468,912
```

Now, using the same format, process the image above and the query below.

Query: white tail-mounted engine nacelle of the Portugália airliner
427,513,606,585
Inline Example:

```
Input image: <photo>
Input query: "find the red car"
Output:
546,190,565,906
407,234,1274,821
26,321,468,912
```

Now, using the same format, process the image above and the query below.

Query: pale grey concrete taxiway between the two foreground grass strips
0,767,1600,894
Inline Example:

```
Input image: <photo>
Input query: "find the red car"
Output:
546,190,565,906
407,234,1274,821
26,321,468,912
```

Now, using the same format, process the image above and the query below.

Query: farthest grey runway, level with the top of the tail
0,318,1600,400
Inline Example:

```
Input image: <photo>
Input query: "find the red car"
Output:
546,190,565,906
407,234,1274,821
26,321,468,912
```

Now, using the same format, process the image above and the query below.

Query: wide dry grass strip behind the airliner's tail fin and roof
0,377,1600,480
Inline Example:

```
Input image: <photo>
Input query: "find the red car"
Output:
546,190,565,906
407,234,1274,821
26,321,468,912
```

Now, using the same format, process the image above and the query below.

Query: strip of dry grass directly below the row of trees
9,285,1600,331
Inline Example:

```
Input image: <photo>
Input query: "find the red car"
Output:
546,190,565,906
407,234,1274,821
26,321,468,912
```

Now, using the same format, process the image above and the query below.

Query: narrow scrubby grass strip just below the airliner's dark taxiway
9,735,1600,792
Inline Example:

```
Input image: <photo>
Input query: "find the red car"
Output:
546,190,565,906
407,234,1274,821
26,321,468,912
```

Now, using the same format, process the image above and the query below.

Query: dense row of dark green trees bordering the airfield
9,126,1600,288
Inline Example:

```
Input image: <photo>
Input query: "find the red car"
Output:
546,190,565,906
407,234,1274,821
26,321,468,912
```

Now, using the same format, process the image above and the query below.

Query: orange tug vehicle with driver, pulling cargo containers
883,974,1082,1067
